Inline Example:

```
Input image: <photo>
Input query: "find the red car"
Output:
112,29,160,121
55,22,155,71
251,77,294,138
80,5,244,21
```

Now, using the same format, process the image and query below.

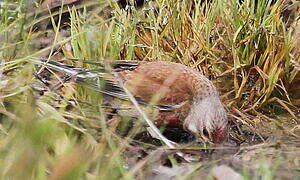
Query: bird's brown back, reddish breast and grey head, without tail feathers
114,61,227,142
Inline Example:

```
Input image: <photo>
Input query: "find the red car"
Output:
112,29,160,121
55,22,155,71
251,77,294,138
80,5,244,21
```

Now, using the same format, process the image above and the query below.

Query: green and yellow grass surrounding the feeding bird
0,0,300,179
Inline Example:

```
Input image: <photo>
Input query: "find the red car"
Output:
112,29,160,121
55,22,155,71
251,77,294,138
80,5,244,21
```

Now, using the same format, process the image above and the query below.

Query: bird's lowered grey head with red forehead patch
183,94,228,143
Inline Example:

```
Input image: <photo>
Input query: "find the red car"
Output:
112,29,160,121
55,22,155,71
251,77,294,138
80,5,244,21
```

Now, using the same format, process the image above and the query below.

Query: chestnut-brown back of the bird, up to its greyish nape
118,61,216,105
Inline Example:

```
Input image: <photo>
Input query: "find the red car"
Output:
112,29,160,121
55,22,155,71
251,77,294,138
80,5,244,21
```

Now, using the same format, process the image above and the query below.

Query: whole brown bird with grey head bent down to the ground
34,59,228,143
